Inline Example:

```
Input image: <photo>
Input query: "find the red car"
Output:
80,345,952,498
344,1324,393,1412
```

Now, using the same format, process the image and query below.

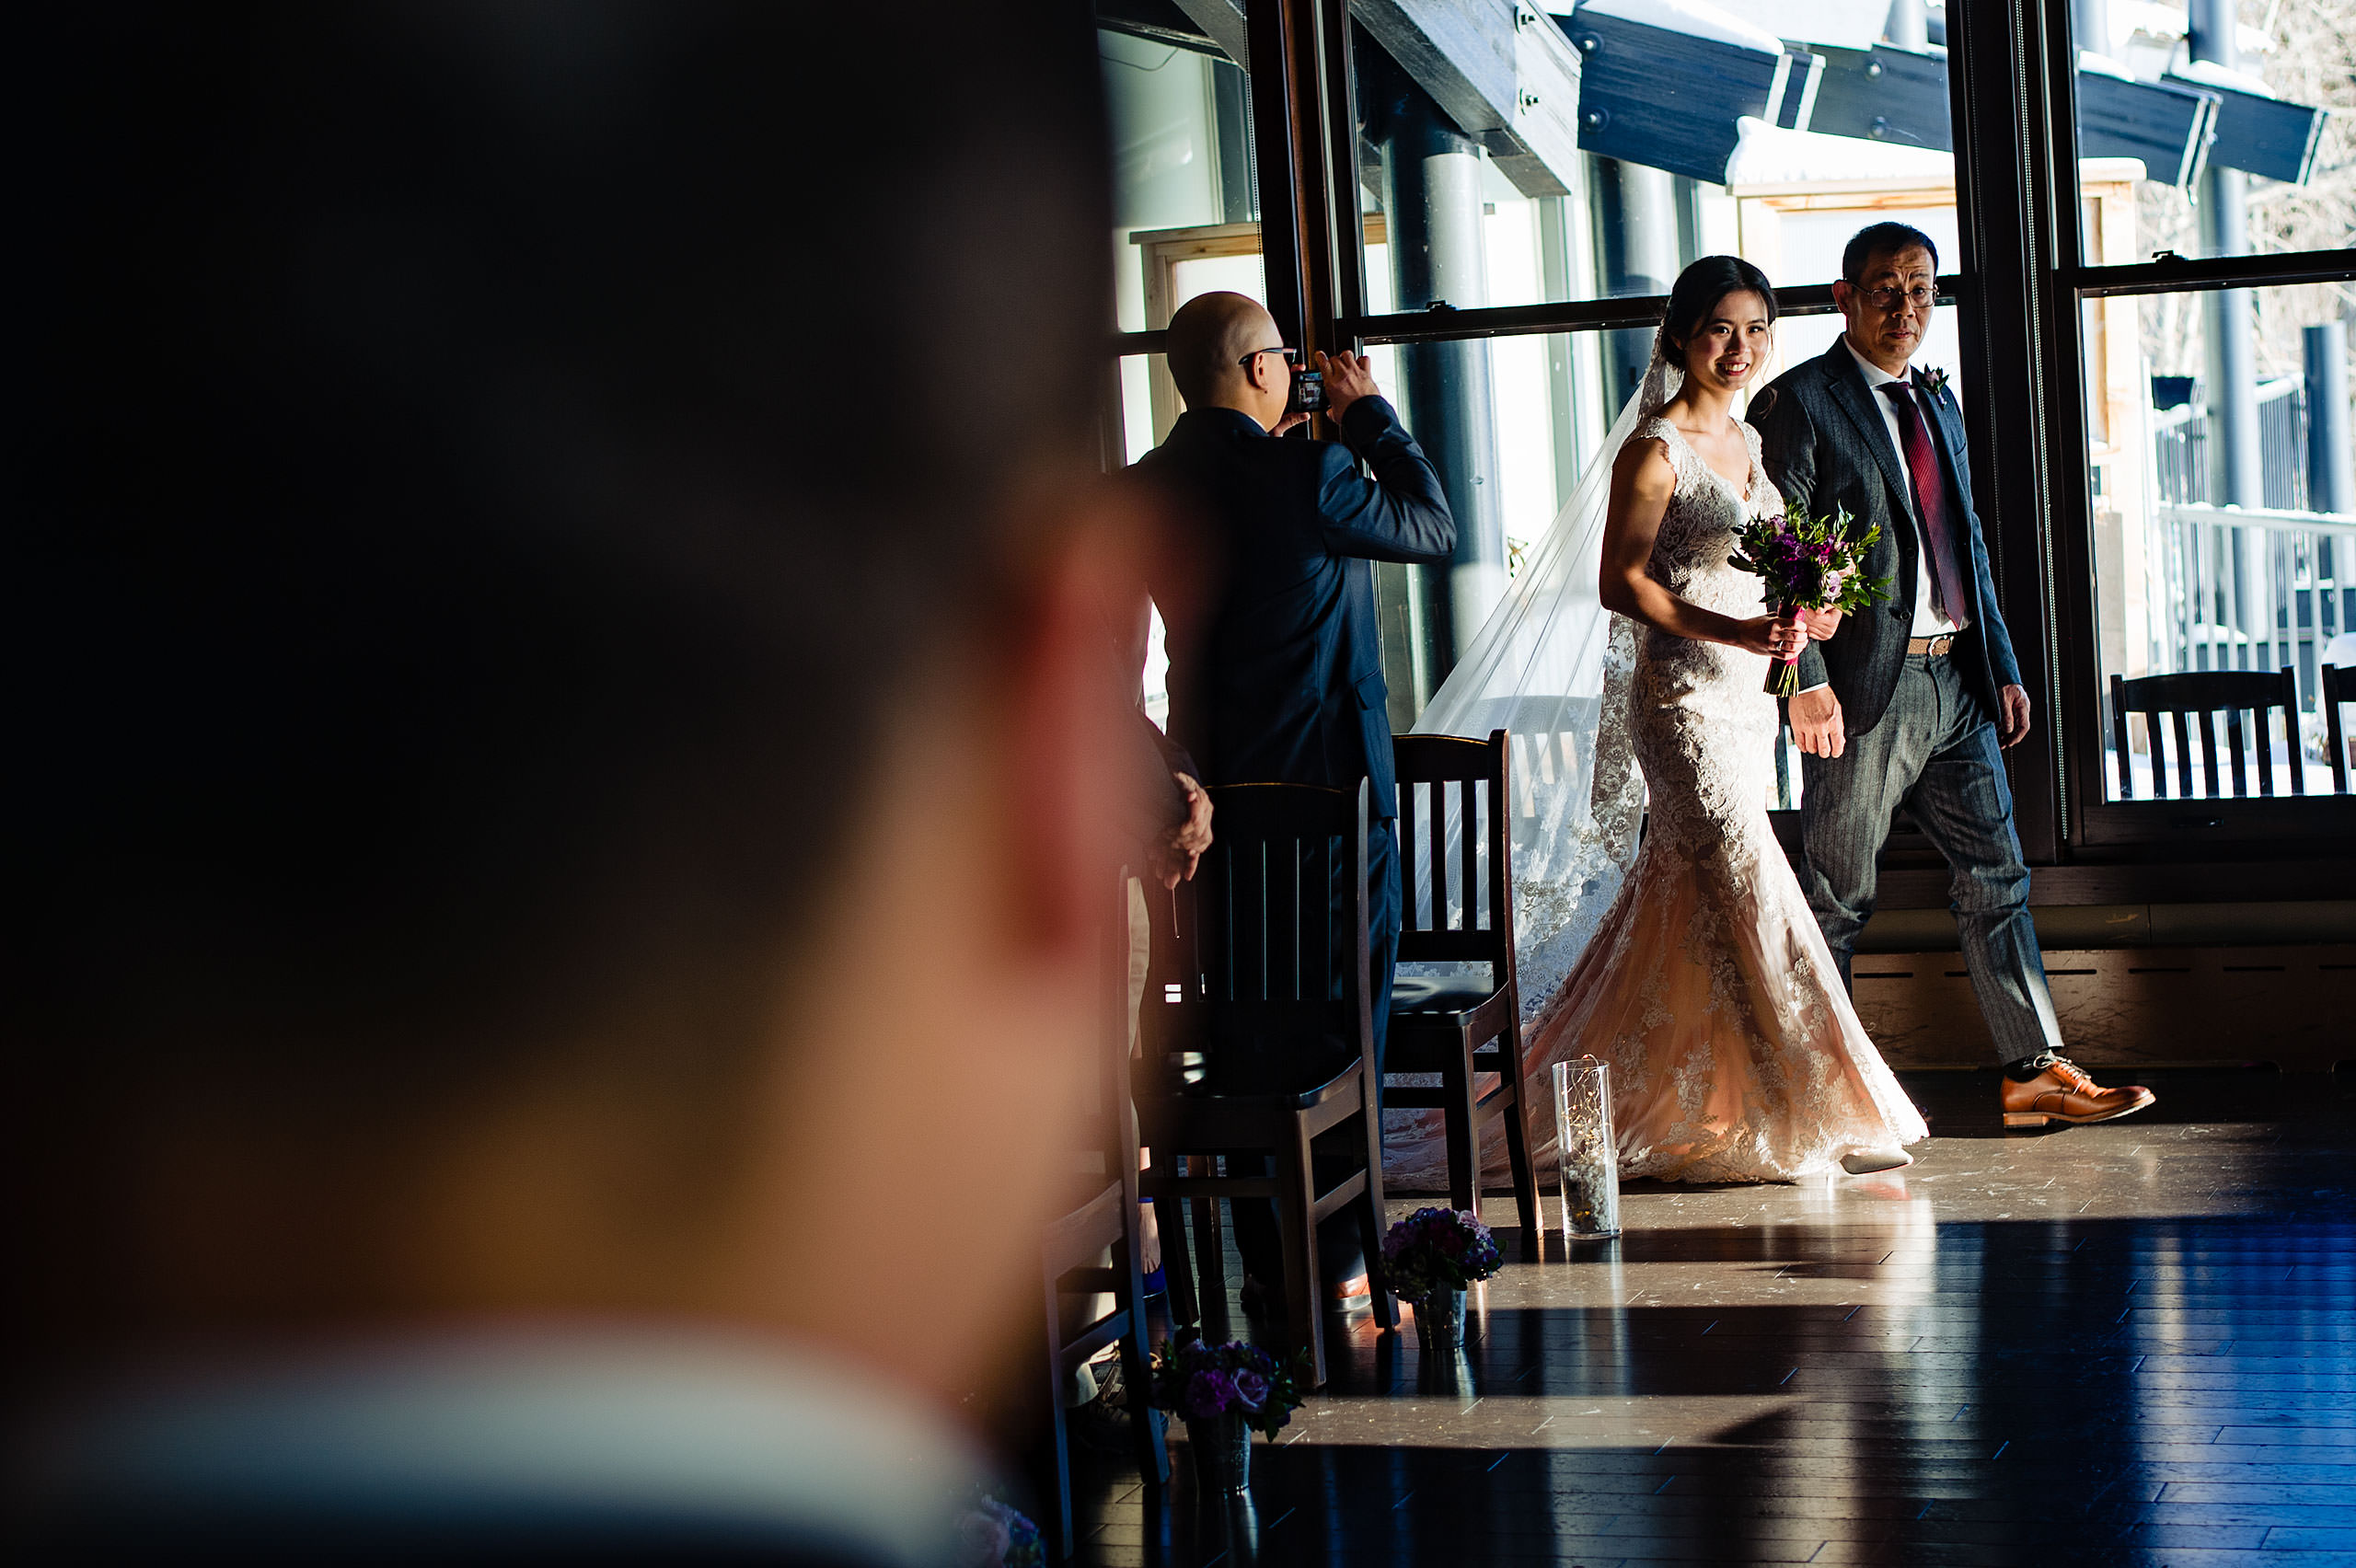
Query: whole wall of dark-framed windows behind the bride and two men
1098,0,2356,861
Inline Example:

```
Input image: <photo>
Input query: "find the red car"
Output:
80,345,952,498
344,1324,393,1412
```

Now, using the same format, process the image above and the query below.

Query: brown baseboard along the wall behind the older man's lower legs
1854,941,2356,1071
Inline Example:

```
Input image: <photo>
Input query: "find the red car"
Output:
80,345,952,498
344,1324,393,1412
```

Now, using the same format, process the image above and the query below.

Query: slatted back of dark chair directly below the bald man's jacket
1145,784,1373,1073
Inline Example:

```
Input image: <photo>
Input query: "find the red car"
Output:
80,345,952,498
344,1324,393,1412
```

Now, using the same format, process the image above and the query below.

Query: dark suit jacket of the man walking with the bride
1750,337,2021,734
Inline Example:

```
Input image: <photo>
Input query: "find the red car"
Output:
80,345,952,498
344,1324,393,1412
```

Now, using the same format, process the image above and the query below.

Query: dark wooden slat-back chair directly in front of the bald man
1138,781,1397,1384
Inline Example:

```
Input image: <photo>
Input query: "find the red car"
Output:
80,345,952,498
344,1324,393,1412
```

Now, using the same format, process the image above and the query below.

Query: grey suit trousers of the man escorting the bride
1800,654,2062,1062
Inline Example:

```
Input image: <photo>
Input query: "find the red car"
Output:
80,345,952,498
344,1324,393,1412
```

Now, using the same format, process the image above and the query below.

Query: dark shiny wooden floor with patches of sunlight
1081,1071,2356,1568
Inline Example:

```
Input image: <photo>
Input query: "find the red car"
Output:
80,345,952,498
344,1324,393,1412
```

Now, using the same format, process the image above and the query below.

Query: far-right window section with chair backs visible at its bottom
2048,0,2356,846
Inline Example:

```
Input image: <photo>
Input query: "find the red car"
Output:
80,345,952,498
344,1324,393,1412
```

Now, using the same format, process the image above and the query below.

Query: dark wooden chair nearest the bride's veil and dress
1383,730,1541,1257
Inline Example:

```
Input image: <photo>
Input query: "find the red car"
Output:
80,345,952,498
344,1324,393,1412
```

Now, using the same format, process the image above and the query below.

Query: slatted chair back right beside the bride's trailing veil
1390,730,1517,970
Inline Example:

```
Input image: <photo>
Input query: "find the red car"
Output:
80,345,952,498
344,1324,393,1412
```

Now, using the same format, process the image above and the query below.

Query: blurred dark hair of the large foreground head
0,0,1112,1158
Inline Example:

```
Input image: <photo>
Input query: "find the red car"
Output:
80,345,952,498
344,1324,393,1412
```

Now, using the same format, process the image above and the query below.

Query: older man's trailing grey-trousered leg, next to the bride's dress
1800,659,1936,984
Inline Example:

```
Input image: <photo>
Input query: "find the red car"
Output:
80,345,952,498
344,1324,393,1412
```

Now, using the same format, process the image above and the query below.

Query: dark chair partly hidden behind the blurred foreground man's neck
1034,873,1171,1556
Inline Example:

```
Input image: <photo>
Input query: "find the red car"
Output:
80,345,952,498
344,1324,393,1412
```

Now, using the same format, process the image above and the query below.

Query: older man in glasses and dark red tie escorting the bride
1750,224,2151,1125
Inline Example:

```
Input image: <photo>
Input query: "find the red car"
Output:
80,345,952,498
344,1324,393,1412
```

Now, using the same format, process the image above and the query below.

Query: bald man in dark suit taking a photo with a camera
1138,294,1456,1302
